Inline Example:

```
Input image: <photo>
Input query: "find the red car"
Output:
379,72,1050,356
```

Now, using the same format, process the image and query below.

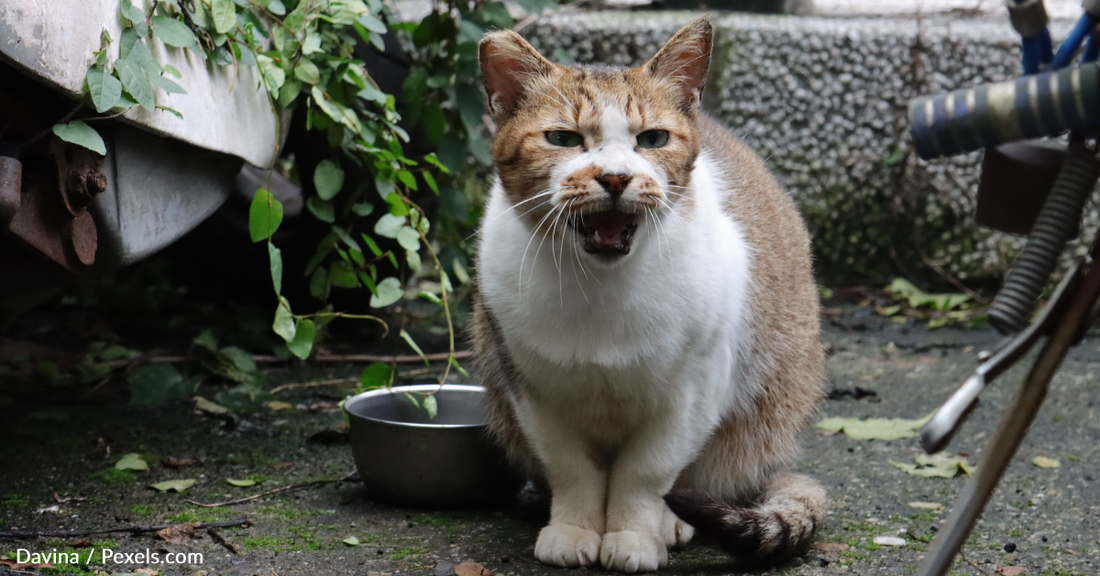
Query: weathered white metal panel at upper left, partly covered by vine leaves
0,0,278,167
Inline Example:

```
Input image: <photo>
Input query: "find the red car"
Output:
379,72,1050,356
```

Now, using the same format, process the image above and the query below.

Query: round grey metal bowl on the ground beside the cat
344,384,521,506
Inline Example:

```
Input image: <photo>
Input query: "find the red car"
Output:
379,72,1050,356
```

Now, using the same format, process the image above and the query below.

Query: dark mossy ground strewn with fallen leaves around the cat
0,292,1100,576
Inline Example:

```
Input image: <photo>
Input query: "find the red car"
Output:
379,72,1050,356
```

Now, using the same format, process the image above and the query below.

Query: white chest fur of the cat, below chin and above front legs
479,156,750,400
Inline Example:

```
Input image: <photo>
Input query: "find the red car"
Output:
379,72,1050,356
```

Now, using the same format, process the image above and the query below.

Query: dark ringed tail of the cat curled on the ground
664,474,826,564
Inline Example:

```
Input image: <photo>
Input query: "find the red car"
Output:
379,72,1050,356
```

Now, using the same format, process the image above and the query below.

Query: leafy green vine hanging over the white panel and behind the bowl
54,0,557,404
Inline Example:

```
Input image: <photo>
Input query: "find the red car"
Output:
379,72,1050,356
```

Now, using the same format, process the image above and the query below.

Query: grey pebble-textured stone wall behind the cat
524,12,1100,285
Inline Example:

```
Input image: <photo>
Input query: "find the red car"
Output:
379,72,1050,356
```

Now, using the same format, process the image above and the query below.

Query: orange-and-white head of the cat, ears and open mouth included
481,20,711,263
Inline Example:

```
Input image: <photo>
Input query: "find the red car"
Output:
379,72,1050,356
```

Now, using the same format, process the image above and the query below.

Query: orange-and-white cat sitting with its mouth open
473,19,826,573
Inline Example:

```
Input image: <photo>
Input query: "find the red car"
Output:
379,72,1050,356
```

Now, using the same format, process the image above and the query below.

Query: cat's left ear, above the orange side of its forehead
477,30,553,115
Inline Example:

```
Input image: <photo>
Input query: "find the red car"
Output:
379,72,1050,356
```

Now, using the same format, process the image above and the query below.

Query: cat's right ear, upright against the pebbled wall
645,18,714,113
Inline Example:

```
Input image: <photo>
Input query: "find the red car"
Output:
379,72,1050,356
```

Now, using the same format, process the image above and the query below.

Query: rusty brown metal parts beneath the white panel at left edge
0,137,107,272
